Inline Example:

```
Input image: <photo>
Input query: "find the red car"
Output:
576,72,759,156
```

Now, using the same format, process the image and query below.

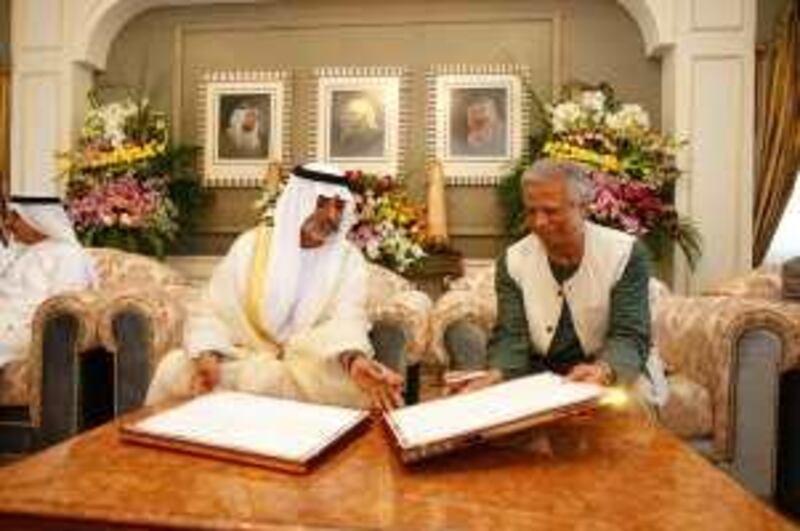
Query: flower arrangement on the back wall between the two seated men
347,171,427,273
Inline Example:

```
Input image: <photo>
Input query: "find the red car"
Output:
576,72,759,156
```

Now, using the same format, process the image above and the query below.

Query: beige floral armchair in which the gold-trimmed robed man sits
98,251,432,411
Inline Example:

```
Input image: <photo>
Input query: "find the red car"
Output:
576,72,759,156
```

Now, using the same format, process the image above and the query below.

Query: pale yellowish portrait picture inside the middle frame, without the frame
328,90,386,159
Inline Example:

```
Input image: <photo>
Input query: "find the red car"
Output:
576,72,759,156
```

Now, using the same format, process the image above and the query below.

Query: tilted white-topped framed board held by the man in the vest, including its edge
384,373,606,463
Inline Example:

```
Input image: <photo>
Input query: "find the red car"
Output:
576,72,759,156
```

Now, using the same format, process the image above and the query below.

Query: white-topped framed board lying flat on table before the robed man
120,391,369,473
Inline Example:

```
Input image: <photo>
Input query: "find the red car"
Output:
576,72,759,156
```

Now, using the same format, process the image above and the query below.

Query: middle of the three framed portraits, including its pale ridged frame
309,67,408,175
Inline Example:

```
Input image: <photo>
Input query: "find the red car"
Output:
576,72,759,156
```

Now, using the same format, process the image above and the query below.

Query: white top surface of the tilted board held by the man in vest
387,373,604,448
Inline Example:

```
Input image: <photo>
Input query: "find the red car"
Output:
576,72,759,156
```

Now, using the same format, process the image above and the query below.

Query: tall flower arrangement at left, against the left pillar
58,95,199,256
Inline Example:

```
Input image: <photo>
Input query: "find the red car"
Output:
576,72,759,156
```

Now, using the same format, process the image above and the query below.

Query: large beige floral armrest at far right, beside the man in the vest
653,296,800,462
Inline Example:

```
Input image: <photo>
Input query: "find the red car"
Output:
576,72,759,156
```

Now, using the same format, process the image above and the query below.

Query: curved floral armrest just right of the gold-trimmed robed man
369,289,433,365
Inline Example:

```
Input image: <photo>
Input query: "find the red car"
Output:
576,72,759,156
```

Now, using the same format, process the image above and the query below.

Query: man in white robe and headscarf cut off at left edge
0,196,95,370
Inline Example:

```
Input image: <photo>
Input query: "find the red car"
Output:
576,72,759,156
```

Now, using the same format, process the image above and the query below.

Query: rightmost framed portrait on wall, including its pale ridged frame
427,65,530,186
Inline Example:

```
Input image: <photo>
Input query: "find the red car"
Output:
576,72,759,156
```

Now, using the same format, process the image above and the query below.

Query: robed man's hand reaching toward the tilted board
341,352,403,411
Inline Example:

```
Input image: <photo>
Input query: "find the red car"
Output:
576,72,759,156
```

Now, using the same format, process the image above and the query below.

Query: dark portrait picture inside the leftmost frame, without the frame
217,94,272,159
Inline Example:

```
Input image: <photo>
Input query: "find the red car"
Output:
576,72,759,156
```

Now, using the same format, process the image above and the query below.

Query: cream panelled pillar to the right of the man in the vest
662,0,756,292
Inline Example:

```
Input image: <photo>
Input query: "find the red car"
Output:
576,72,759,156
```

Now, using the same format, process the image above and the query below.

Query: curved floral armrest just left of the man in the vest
431,289,497,367
